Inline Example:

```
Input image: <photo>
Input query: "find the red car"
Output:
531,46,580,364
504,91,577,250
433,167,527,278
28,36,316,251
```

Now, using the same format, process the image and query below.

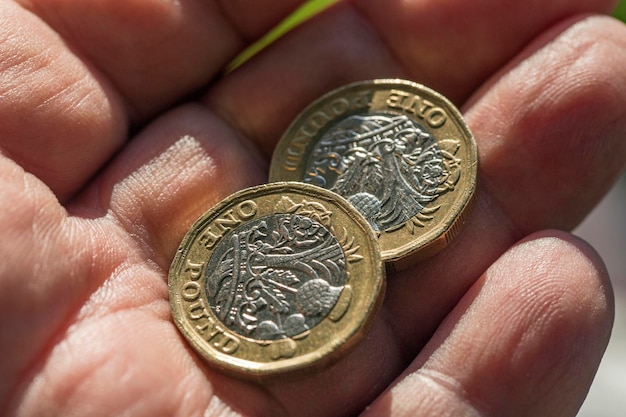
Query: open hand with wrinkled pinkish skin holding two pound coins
0,0,626,417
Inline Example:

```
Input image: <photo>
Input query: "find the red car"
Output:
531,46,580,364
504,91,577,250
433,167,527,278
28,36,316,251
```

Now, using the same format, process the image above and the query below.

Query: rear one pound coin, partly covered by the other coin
269,80,477,267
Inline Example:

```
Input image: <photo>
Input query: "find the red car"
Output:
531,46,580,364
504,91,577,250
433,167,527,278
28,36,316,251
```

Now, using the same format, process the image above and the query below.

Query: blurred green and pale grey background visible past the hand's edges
251,0,626,417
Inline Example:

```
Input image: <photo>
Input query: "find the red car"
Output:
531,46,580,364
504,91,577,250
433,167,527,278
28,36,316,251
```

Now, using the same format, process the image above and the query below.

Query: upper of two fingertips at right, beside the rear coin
466,13,626,233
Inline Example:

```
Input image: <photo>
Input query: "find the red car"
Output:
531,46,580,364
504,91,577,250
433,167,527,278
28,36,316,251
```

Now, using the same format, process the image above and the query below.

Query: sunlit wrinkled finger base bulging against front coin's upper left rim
69,104,267,270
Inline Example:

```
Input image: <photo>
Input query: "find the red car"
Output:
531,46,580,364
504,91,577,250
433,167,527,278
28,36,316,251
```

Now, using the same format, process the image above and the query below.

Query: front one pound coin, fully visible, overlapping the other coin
169,183,385,379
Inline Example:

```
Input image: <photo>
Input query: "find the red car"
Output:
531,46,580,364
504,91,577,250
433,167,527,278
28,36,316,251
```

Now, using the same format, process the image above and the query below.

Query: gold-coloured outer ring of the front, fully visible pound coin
169,182,385,381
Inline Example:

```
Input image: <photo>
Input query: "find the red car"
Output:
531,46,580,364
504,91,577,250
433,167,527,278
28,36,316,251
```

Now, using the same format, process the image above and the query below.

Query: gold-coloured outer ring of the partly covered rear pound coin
269,79,478,269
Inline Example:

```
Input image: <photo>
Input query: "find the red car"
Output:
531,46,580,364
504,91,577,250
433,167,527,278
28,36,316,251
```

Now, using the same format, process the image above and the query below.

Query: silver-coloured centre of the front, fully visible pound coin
207,214,346,340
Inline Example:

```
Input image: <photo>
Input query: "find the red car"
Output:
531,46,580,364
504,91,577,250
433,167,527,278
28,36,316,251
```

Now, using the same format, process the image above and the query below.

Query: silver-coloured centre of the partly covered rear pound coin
303,113,445,231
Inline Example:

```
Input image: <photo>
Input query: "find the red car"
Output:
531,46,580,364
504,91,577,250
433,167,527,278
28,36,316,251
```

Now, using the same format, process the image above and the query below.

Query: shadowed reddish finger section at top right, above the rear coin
356,0,615,102
